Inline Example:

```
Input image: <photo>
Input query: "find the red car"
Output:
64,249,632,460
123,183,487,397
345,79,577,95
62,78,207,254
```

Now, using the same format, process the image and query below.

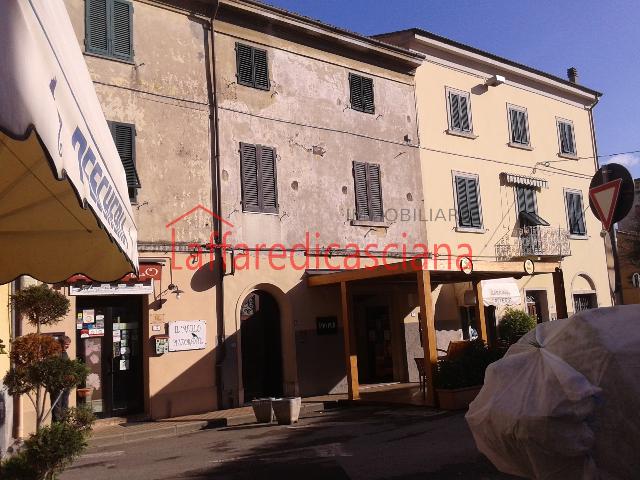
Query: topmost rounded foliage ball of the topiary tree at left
11,284,69,333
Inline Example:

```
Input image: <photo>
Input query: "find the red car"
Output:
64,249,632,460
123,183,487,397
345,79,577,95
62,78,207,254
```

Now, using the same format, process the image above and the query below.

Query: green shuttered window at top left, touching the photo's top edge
85,0,133,61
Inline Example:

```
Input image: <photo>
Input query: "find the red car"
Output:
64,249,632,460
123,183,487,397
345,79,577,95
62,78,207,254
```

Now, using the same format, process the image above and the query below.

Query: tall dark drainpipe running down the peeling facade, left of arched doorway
205,0,227,409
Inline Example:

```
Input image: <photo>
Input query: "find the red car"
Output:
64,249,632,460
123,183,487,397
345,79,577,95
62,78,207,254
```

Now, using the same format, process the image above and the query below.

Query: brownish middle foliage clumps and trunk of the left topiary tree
4,333,89,431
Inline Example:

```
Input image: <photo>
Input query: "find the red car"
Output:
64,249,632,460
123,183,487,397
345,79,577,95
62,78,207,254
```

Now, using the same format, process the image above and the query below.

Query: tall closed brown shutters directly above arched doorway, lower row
240,143,278,213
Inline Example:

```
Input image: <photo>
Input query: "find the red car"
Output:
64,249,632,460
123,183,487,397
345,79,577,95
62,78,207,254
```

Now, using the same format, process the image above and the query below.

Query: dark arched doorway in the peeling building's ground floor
240,290,282,402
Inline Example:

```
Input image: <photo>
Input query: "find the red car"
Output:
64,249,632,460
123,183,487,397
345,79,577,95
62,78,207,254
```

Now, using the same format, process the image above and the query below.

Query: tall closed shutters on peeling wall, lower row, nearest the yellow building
353,162,384,222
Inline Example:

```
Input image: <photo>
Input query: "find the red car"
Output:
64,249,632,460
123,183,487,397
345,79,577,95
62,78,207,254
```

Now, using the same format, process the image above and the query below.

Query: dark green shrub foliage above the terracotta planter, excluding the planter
435,339,504,389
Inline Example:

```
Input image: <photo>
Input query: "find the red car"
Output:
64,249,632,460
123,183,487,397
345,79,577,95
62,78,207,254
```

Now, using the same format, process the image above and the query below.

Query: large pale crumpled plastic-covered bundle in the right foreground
466,305,640,480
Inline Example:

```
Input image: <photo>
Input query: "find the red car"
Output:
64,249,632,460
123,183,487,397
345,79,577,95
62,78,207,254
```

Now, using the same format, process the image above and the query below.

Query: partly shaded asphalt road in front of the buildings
62,407,515,480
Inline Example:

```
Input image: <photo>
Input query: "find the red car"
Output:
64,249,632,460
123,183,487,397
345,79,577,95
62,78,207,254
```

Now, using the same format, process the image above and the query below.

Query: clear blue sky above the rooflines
266,0,640,178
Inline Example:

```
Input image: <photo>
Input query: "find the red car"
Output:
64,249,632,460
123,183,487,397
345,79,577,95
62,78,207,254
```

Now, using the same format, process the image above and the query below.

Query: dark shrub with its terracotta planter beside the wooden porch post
435,339,502,410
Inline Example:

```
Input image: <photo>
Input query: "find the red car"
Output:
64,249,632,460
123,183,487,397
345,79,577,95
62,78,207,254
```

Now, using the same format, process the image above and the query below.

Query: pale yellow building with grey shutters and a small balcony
377,29,612,340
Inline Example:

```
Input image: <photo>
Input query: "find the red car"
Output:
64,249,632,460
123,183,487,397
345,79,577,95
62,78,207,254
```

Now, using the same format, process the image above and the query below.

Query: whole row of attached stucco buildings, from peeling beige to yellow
7,0,611,433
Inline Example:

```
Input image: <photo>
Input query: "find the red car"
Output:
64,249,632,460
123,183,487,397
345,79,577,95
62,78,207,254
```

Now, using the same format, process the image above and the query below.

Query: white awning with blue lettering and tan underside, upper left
0,0,138,283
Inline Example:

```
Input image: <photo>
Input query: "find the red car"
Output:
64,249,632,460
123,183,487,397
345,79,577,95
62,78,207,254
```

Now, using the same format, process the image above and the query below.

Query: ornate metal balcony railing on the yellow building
496,226,571,261
